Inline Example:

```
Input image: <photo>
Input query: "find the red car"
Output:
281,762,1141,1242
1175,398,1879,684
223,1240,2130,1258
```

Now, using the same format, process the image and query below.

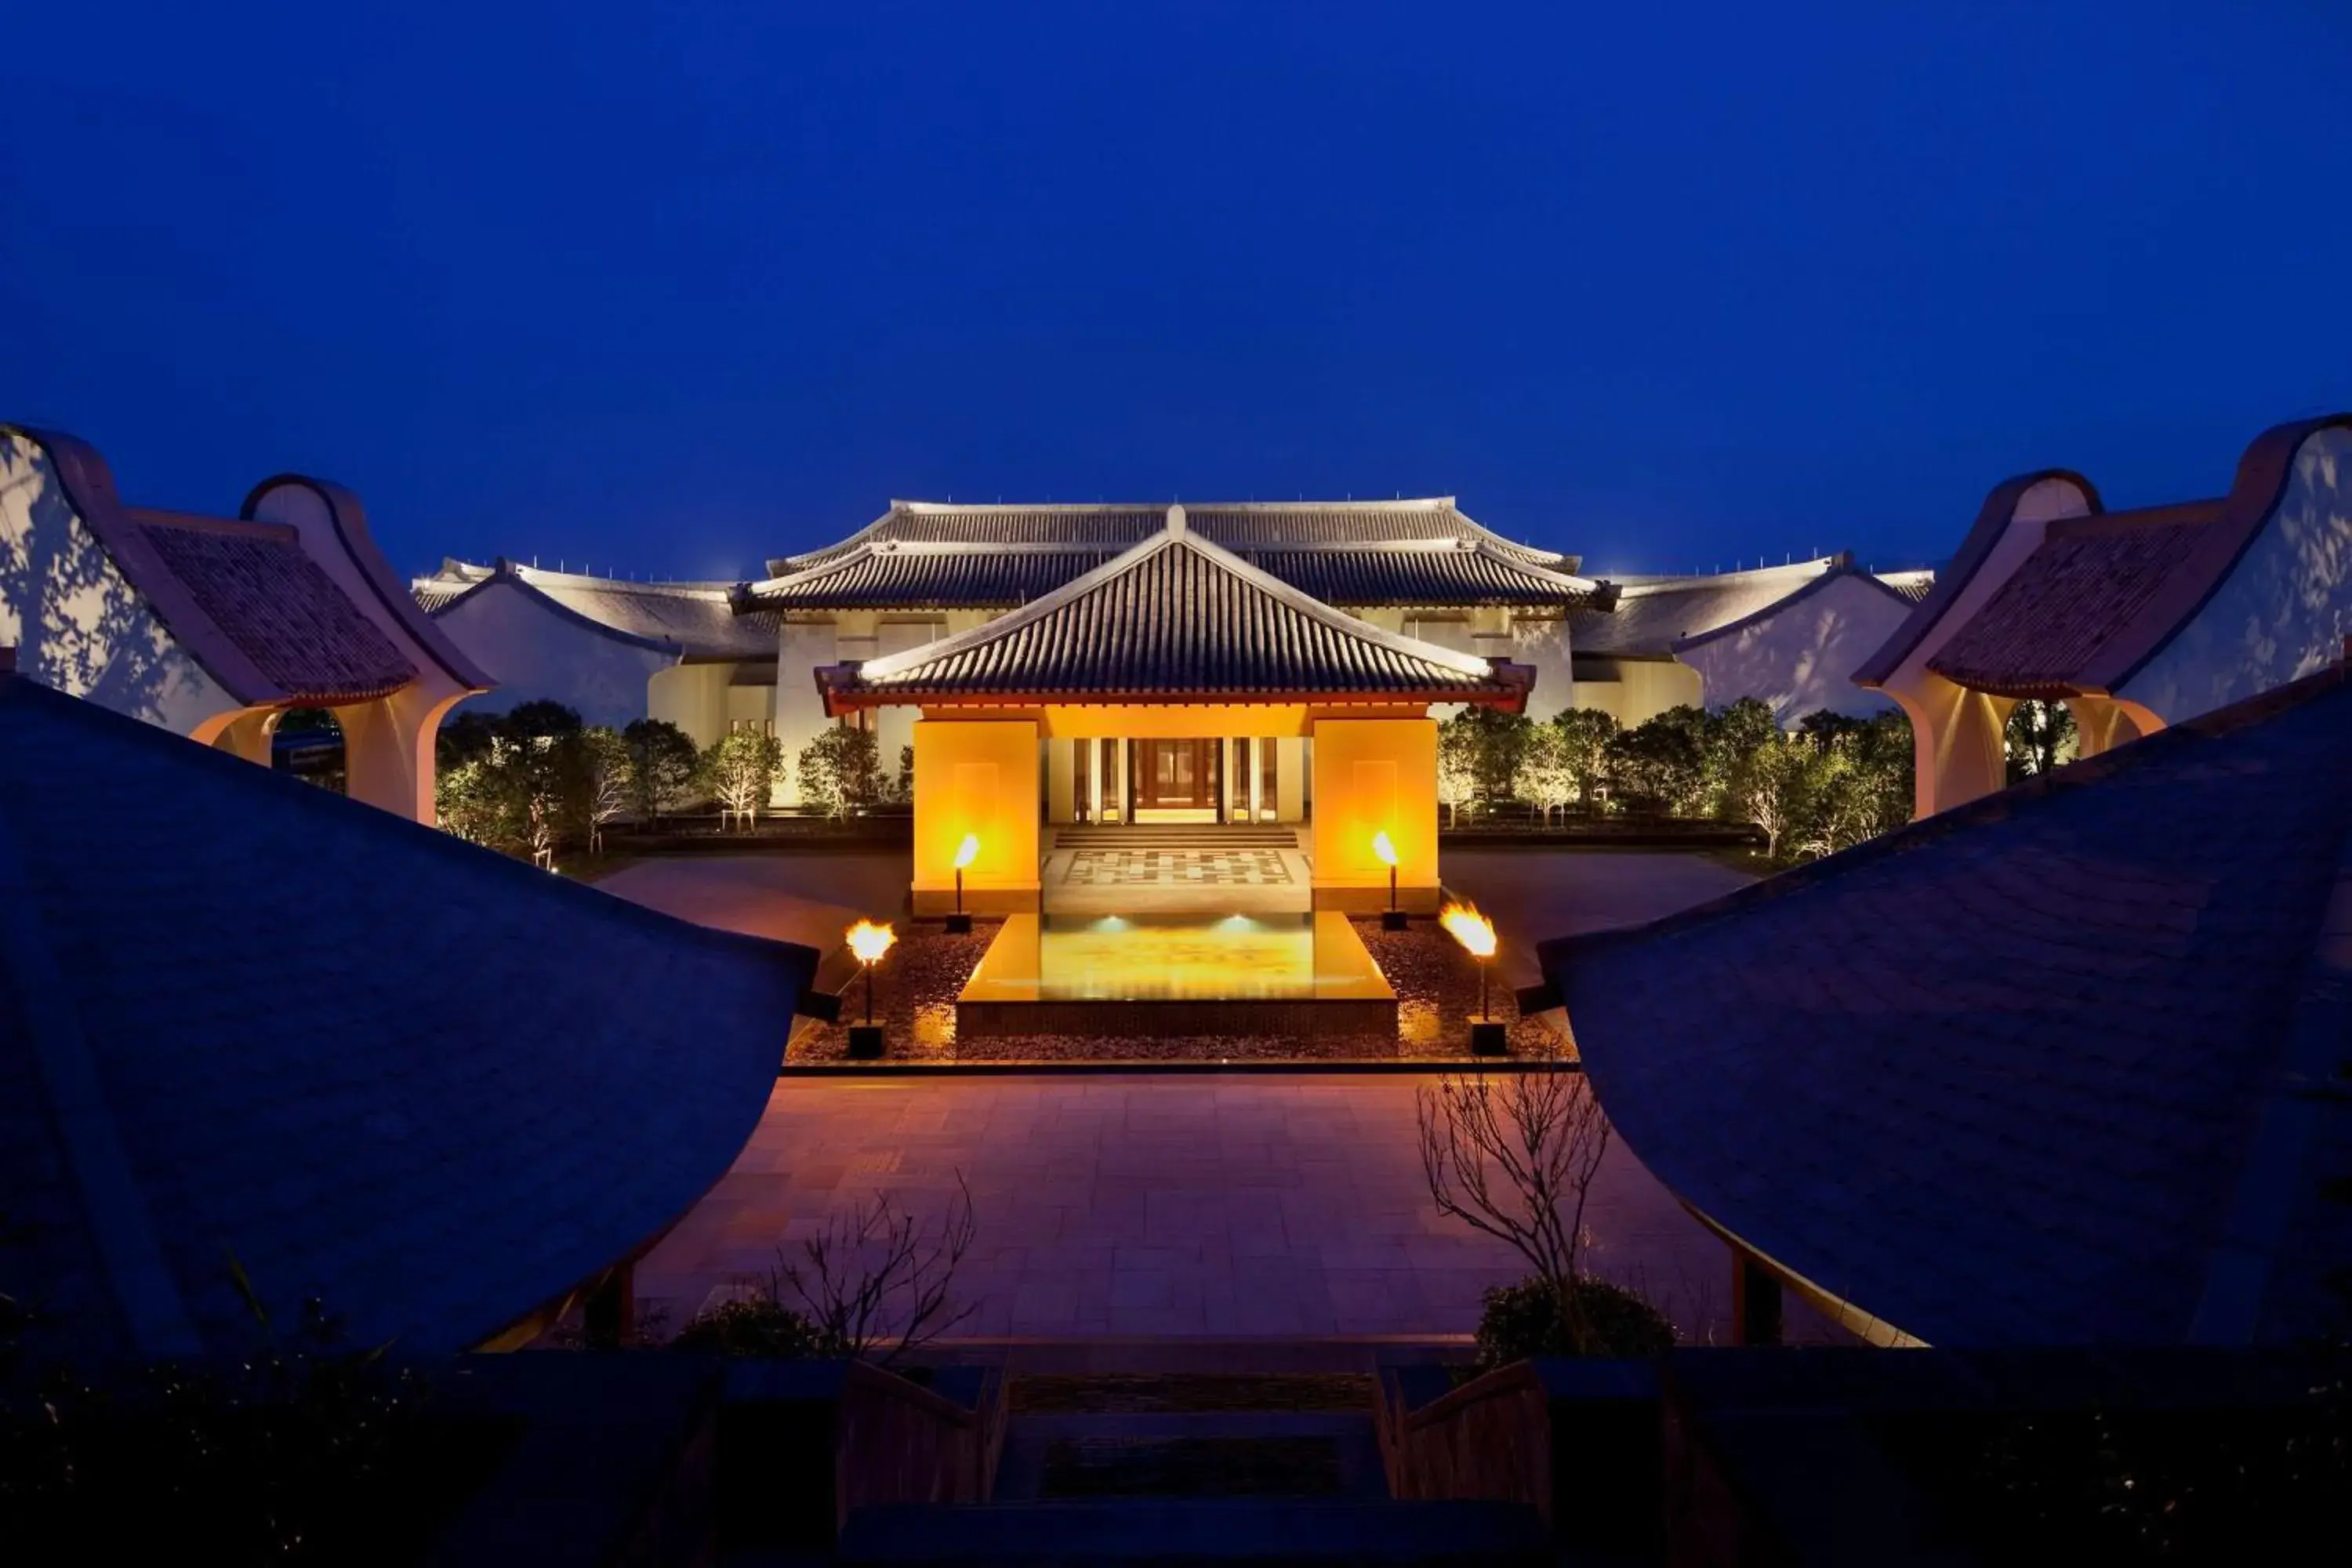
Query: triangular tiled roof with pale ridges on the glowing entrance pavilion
818,508,1526,708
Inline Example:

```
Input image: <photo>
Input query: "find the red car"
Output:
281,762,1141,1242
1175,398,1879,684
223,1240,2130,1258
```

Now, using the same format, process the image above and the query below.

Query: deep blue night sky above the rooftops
0,0,2352,576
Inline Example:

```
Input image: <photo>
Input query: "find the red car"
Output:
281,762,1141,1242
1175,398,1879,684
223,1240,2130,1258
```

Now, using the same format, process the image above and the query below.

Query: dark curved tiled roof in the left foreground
0,677,816,1359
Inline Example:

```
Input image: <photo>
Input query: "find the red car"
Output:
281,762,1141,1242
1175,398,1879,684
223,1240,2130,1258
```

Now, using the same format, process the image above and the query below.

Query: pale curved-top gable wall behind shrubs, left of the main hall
435,579,673,729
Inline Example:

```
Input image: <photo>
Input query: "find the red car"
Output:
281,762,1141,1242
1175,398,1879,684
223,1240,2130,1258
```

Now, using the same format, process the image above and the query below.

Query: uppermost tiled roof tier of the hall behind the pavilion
788,496,1573,572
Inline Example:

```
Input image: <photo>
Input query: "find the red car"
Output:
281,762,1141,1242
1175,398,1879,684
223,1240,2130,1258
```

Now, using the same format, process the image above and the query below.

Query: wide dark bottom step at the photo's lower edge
837,1497,1552,1568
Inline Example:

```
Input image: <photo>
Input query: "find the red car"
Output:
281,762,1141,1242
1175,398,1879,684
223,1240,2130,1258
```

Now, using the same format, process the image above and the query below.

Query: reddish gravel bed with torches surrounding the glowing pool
786,919,1566,1065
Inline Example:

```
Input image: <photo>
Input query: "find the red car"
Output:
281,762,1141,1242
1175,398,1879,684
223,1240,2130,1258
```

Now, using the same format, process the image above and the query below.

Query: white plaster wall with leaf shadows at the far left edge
0,433,240,736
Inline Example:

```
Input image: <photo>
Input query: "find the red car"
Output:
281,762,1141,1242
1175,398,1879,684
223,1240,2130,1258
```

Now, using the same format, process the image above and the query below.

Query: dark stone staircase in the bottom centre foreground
837,1375,1555,1568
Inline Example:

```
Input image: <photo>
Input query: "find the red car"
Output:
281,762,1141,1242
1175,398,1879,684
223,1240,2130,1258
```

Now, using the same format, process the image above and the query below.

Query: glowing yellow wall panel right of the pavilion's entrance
1315,720,1437,912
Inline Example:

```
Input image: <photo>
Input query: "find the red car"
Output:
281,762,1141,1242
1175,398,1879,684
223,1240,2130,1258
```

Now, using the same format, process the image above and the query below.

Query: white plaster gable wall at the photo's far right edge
2117,428,2352,724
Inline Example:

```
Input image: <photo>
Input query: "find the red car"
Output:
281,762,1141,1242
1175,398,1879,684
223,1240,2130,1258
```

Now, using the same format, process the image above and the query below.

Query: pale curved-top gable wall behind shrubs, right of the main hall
1682,574,1910,727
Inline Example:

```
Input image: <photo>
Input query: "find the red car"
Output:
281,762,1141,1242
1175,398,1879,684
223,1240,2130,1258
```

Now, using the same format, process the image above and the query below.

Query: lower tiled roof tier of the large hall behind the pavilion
743,540,1592,609
